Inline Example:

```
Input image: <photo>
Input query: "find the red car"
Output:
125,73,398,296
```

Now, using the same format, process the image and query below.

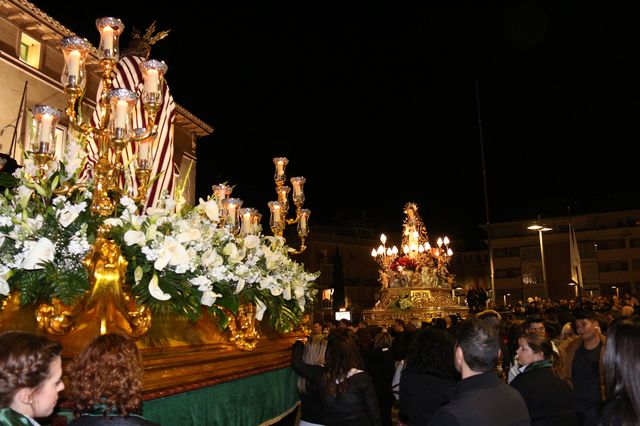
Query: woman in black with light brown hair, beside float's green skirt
291,334,327,426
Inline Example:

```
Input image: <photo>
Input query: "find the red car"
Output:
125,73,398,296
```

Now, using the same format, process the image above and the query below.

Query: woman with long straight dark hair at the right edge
585,317,640,426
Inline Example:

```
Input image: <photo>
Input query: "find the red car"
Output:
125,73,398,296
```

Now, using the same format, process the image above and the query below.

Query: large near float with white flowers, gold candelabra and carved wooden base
0,18,317,397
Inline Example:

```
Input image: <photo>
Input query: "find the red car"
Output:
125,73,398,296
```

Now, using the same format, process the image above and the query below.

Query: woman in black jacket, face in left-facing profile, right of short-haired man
510,333,577,426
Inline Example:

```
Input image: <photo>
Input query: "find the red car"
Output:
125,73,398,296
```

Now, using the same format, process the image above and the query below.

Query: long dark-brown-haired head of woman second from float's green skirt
322,330,363,396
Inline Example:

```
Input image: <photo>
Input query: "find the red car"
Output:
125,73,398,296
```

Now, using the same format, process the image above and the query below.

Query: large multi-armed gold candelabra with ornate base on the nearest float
24,17,167,336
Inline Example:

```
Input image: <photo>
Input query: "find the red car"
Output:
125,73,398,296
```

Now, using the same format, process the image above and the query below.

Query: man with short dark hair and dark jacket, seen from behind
429,318,531,426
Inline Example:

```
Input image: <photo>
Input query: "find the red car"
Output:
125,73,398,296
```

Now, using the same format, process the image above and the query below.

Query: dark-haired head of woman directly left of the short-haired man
406,327,455,379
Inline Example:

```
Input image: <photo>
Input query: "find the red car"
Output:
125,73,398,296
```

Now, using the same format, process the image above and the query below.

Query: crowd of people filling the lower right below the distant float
292,295,640,426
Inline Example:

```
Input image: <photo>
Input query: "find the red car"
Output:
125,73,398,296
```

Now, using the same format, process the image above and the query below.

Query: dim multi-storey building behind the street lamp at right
453,210,640,306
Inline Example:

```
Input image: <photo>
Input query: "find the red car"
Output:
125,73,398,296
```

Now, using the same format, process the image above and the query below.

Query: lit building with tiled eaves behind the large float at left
0,0,213,204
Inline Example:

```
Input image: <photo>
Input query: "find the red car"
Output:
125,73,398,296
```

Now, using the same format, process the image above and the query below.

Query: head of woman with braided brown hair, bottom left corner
0,331,64,418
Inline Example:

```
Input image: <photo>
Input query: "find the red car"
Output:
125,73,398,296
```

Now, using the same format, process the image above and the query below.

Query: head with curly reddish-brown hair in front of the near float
68,333,143,416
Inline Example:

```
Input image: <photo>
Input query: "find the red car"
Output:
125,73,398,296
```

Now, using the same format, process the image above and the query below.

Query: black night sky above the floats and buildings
35,0,640,246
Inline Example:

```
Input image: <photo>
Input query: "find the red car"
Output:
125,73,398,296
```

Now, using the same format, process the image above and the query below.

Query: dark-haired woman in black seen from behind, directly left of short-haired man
400,328,456,425
